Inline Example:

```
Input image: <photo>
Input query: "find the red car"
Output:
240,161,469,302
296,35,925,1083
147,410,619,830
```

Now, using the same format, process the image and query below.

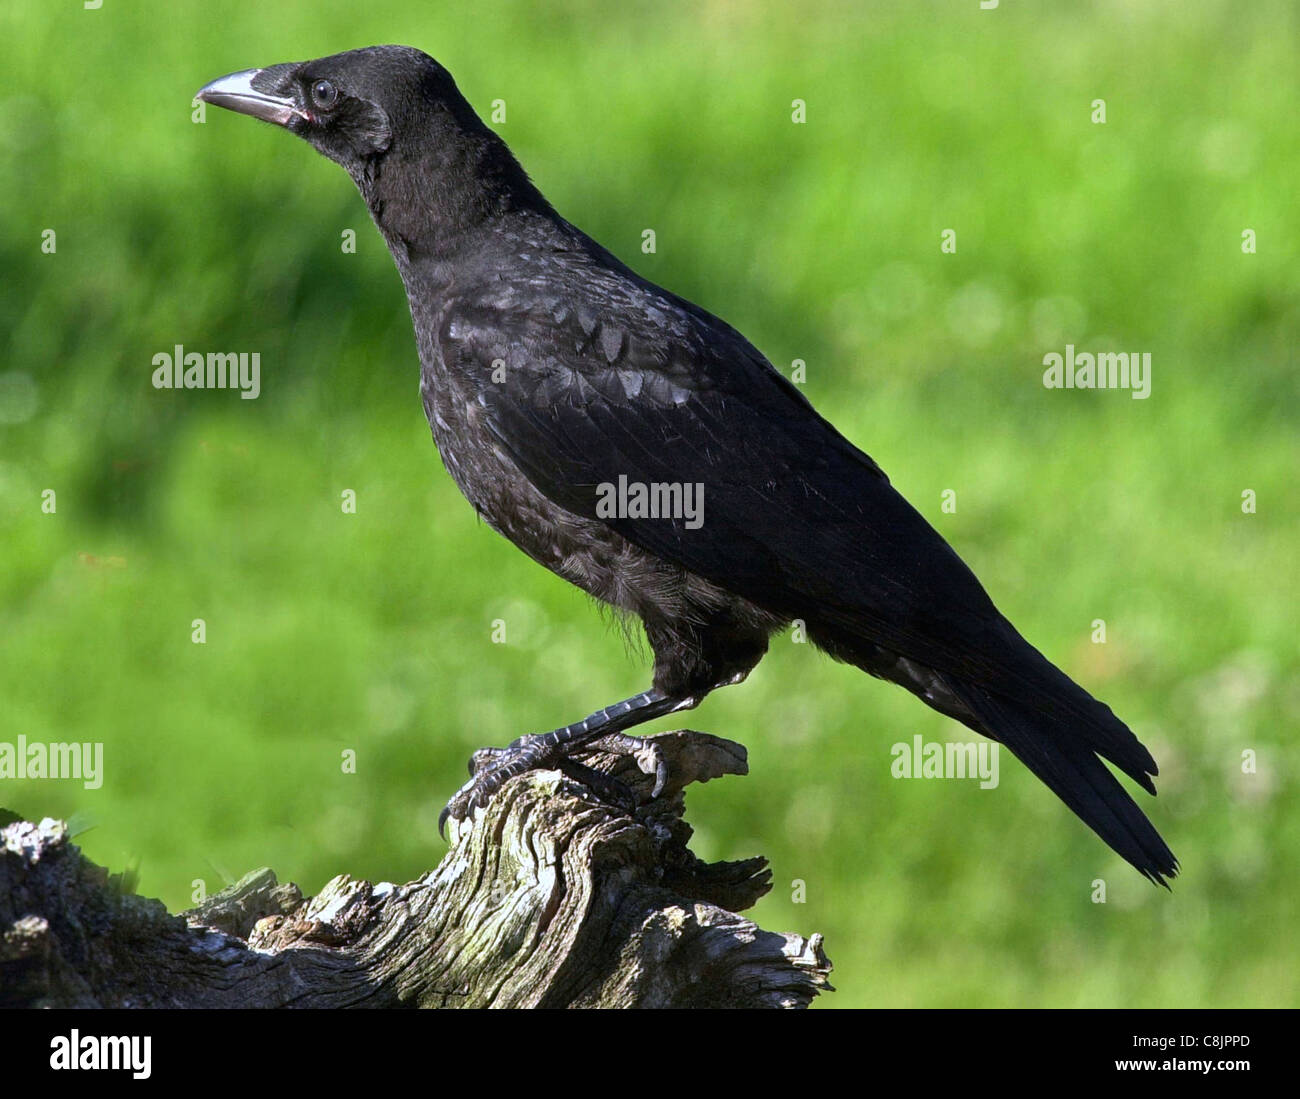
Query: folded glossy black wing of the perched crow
441,284,1014,682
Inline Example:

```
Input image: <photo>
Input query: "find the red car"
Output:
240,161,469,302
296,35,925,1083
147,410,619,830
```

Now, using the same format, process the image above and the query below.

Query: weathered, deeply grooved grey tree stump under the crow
0,732,831,1008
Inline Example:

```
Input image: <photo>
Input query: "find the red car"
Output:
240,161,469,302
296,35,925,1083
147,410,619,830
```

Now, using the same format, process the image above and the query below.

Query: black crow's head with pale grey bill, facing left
198,46,546,243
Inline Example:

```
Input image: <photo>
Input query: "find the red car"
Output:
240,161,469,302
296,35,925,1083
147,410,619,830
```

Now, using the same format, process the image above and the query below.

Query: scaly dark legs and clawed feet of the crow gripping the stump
438,689,699,834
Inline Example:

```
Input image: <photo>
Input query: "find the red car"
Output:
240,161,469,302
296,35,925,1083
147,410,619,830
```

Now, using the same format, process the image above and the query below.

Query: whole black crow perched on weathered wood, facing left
198,46,1178,888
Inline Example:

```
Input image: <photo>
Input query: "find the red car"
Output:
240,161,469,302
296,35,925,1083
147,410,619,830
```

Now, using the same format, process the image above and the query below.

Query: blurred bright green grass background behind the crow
0,0,1300,1007
